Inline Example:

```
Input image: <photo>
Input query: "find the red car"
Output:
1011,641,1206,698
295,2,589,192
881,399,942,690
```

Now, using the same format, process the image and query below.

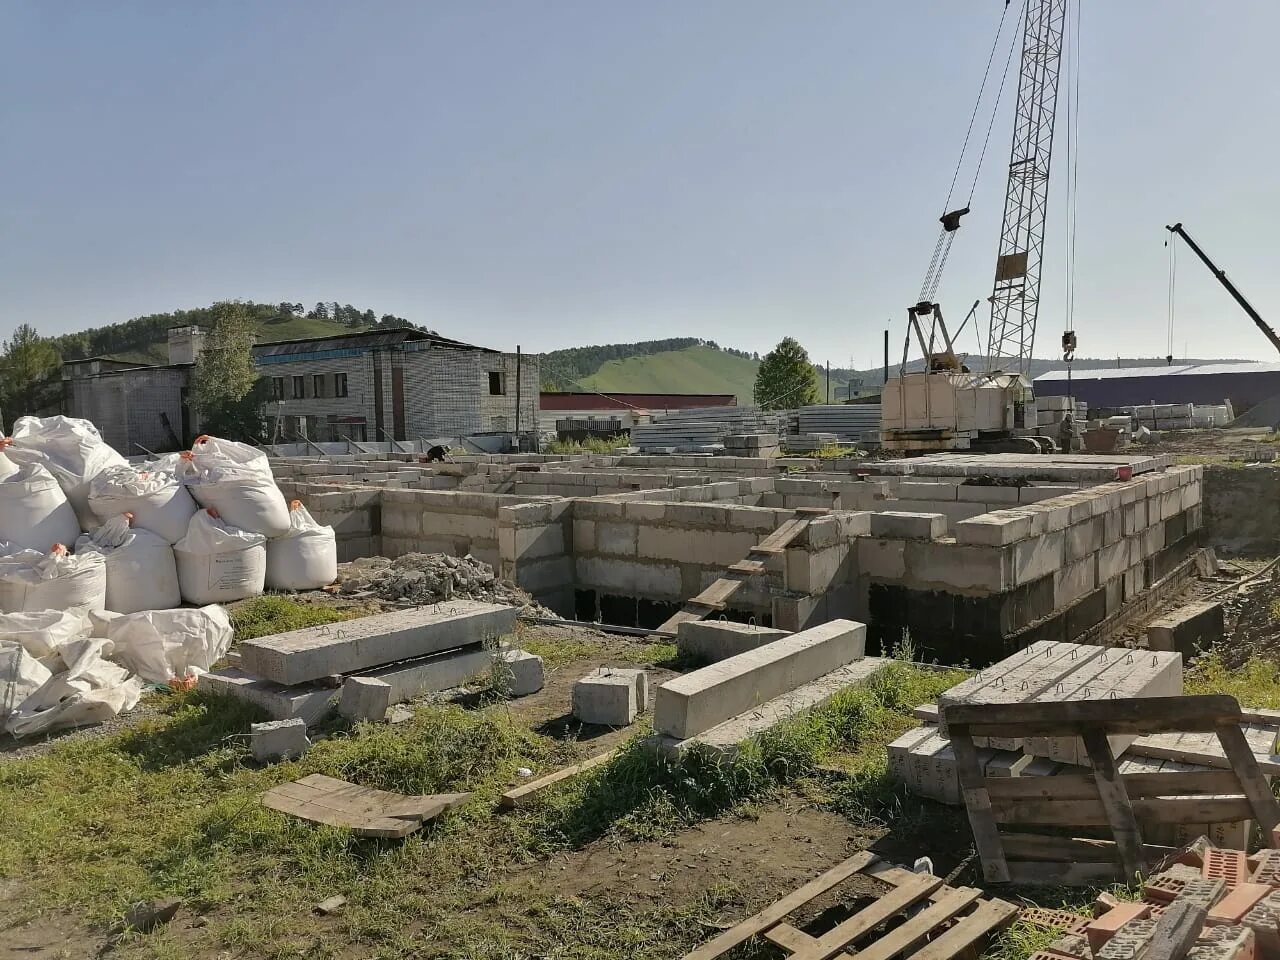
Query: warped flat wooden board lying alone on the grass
262,773,471,838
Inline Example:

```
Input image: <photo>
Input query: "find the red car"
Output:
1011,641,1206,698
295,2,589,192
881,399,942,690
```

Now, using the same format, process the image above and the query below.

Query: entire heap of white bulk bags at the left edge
0,417,338,736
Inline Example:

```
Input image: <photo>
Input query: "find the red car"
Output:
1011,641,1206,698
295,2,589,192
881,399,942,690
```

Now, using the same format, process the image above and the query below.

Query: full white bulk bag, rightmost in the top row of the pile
178,436,289,536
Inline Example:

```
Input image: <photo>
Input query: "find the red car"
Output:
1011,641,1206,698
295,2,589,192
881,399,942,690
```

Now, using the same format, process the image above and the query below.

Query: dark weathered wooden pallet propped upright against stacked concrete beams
943,695,1280,883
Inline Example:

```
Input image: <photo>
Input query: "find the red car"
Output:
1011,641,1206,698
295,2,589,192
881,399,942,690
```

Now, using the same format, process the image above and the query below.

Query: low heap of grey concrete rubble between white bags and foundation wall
338,553,540,616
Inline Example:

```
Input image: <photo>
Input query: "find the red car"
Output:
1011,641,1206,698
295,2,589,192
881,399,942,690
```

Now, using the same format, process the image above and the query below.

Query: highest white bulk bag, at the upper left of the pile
6,417,127,529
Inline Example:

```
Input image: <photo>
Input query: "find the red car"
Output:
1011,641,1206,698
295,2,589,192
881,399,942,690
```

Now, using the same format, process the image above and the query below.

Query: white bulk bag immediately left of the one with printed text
76,513,182,613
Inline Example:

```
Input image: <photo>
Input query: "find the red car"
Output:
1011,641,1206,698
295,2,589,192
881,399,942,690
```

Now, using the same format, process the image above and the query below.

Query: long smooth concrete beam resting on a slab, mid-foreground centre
654,620,867,740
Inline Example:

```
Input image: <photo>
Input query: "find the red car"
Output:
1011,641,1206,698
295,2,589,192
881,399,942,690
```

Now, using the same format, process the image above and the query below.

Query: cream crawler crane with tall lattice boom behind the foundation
881,0,1070,453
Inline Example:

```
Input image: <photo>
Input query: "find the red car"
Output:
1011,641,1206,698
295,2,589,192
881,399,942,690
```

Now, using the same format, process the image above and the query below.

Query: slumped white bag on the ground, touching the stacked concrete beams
108,604,232,684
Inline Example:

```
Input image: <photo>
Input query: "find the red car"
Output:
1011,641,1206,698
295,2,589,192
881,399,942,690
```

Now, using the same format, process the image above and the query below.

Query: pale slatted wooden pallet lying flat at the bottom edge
685,851,1018,960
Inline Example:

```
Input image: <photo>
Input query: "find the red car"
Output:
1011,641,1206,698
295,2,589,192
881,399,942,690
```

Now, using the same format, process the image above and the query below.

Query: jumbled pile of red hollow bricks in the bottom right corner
1023,837,1280,960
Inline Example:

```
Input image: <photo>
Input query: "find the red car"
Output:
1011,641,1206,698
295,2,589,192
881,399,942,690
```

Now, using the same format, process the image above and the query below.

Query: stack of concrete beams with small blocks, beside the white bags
198,600,520,723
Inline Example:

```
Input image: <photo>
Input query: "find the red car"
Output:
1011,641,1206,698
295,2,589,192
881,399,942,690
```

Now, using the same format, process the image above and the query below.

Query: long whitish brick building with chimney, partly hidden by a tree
63,328,539,453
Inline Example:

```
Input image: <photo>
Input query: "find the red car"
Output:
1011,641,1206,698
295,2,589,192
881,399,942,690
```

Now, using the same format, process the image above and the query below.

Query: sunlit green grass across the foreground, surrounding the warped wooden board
0,644,959,959
